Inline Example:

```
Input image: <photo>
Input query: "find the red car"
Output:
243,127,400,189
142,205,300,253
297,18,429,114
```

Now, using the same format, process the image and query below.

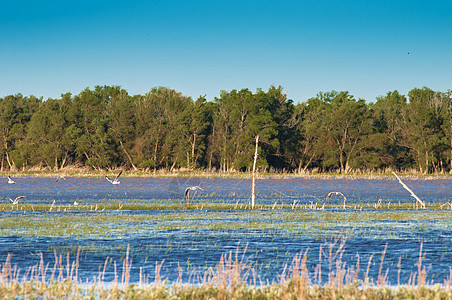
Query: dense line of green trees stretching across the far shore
0,86,452,173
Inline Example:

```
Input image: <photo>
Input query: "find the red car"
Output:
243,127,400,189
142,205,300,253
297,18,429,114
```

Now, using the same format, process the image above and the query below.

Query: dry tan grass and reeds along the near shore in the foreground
0,248,452,299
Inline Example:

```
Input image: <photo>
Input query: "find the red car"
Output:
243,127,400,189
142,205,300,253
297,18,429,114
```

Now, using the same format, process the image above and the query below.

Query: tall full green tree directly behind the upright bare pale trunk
211,89,279,171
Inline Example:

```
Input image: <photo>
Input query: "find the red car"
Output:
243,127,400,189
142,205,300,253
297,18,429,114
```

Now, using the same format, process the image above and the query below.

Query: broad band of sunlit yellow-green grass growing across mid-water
0,204,452,239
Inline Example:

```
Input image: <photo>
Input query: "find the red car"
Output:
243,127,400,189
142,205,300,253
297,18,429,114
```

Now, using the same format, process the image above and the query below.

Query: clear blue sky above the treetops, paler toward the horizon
0,0,452,103
